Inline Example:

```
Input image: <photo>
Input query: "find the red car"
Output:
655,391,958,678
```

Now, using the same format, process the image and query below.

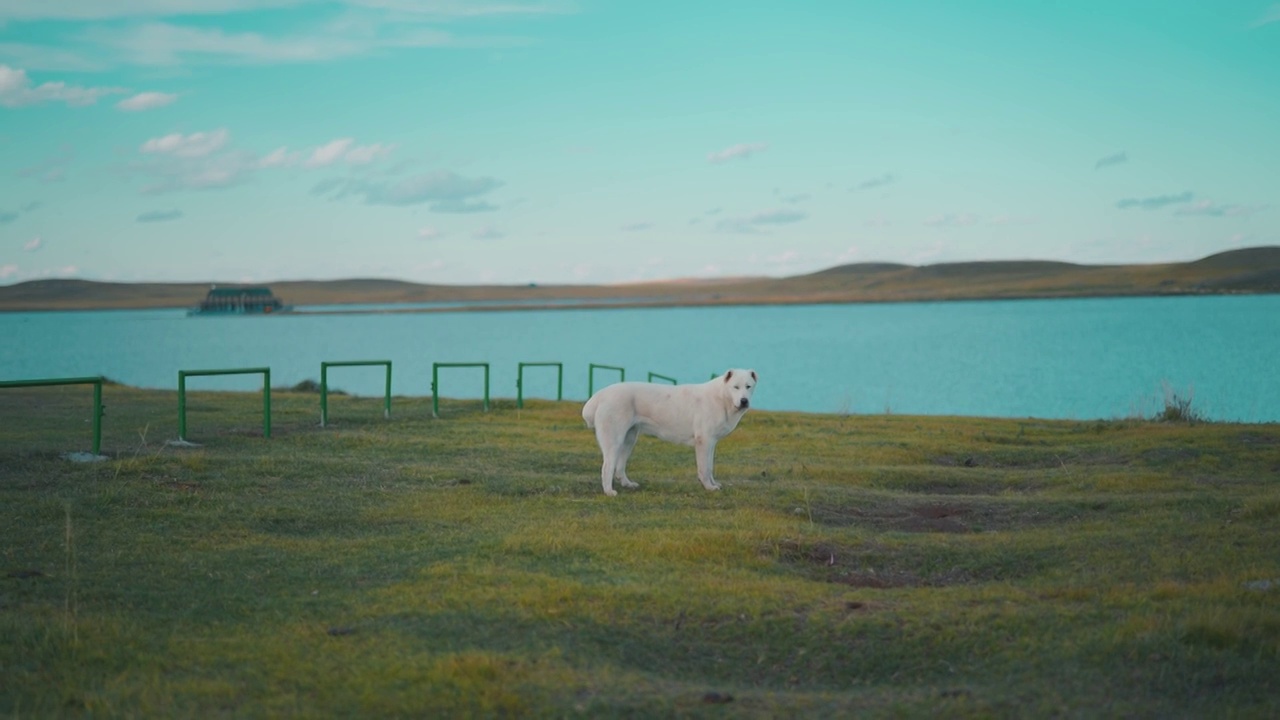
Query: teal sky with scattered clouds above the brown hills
0,0,1280,284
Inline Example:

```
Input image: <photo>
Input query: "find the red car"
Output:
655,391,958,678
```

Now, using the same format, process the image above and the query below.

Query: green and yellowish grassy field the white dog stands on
0,386,1280,717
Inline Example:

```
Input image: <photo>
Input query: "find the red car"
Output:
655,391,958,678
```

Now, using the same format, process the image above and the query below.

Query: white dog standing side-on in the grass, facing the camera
582,369,756,497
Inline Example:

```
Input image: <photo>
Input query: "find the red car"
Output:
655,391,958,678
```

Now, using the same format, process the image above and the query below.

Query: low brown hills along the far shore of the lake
0,247,1280,311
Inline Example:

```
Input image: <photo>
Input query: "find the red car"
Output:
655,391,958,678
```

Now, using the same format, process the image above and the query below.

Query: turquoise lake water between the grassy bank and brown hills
0,295,1280,421
